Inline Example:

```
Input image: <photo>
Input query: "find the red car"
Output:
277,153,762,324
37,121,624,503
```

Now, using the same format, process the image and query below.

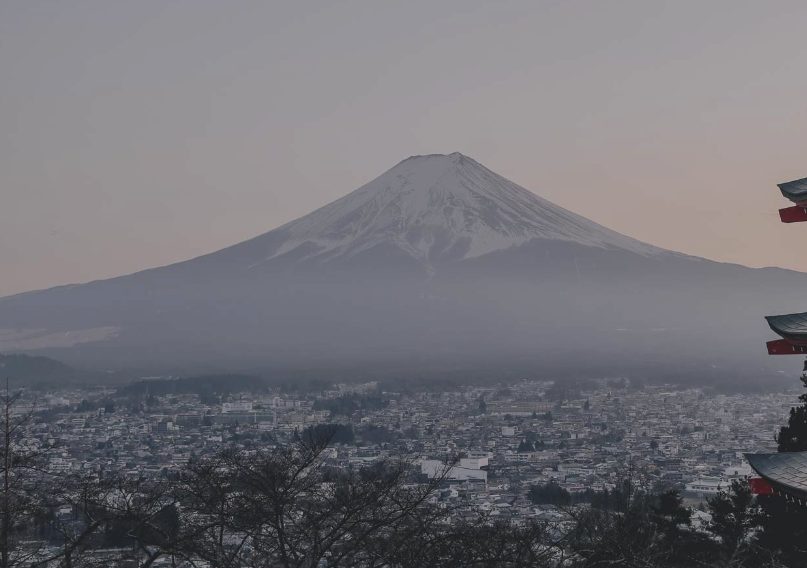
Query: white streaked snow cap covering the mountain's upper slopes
256,153,664,270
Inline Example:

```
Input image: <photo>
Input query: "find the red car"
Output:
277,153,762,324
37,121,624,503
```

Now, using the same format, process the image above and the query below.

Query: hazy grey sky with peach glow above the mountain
0,0,807,295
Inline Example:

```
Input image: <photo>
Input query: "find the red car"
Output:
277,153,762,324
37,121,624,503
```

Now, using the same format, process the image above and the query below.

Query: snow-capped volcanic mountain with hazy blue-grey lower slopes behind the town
0,153,807,382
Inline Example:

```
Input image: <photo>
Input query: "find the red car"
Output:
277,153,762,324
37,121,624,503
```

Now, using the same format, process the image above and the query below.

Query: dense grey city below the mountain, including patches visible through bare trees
4,376,799,567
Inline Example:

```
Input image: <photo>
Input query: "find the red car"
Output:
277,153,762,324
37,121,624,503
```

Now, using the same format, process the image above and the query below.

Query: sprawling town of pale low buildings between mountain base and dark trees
22,378,798,523
